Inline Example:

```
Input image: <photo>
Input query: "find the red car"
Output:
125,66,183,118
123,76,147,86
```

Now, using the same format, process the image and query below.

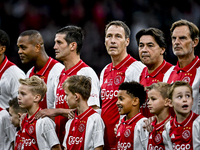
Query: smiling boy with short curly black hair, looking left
116,81,148,150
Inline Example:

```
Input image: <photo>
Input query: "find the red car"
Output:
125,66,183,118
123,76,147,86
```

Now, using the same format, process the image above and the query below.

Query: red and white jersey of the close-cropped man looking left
26,57,64,109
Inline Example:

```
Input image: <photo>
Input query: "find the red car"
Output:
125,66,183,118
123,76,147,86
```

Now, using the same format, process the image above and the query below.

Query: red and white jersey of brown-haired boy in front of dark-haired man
63,107,105,150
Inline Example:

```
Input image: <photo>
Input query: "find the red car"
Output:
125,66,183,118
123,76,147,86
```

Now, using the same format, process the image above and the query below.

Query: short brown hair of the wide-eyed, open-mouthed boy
168,81,193,100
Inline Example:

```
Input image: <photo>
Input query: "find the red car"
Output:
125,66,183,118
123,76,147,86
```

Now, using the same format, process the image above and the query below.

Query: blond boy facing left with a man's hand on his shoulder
18,76,61,150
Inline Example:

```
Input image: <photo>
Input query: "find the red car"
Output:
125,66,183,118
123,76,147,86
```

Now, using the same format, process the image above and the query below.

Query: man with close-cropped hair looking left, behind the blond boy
17,30,64,109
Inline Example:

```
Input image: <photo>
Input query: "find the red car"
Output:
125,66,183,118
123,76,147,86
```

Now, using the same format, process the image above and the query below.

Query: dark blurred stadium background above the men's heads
0,0,200,75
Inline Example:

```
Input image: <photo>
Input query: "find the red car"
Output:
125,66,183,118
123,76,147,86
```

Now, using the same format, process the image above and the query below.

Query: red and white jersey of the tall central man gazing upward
100,55,145,149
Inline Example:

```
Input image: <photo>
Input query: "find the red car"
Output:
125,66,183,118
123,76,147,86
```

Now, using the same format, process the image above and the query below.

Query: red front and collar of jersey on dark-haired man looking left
55,60,88,143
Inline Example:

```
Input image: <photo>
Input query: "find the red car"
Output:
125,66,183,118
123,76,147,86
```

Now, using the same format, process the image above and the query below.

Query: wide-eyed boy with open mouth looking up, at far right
163,81,200,150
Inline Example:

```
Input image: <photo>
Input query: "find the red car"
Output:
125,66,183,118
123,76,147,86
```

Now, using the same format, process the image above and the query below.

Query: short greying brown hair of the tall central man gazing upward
105,20,131,39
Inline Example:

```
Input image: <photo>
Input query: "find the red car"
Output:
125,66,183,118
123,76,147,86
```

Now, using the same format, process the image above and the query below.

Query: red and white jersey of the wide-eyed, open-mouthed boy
163,111,200,150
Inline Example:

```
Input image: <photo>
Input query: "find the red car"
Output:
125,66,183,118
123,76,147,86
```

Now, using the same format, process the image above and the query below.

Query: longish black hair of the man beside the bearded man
136,28,167,49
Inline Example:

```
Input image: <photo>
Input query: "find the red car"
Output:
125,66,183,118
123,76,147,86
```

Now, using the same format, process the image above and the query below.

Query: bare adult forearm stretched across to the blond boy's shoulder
35,108,75,119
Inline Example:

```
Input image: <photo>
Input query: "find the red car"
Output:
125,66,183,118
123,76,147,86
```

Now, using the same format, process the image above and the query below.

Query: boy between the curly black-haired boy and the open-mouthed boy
146,82,171,150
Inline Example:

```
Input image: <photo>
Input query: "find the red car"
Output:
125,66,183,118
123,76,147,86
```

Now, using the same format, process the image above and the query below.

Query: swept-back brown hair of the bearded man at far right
170,19,199,40
